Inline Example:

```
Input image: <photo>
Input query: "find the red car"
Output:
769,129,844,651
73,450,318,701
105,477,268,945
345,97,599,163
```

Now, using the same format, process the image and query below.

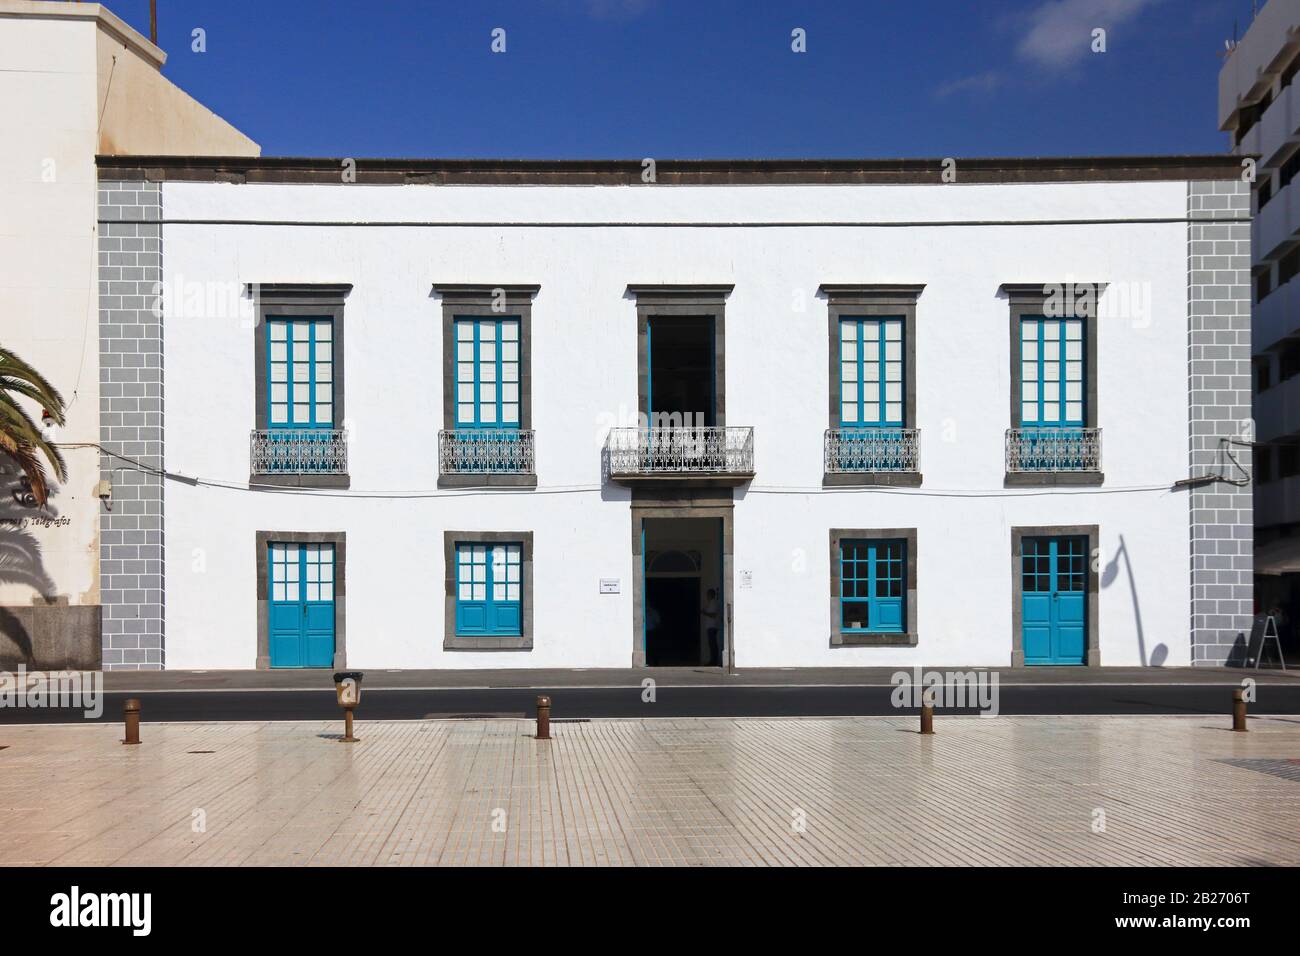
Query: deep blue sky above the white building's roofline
108,0,1251,159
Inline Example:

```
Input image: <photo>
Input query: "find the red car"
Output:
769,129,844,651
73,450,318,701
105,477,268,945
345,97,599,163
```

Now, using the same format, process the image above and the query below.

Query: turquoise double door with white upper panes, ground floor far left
267,542,334,667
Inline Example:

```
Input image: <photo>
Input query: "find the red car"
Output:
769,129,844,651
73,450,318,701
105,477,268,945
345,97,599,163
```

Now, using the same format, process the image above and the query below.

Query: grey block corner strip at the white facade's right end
1187,179,1255,666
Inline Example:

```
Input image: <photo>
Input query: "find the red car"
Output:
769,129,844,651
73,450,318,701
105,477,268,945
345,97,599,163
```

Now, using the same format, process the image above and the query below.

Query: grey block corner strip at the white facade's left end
96,179,166,670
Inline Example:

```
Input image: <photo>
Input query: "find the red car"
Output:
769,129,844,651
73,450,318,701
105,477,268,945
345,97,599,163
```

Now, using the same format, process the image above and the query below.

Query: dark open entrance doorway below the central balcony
642,518,725,667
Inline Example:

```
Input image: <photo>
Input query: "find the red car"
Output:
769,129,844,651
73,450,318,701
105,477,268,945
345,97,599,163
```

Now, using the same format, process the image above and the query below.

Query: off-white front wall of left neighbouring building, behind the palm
0,13,99,606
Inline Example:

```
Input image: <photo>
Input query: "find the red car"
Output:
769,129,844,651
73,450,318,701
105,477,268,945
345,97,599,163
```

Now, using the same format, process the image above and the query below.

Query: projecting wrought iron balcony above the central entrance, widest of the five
605,425,754,485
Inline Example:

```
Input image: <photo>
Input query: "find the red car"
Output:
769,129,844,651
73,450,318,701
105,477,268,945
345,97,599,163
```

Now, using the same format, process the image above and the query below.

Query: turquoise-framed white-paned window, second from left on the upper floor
456,316,520,428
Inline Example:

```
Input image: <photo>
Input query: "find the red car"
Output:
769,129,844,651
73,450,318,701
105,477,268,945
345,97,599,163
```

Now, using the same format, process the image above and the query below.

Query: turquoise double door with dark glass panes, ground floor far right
1021,536,1088,665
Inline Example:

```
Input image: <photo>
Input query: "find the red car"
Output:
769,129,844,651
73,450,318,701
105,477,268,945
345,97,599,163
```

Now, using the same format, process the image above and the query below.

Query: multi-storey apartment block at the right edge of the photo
1218,0,1300,642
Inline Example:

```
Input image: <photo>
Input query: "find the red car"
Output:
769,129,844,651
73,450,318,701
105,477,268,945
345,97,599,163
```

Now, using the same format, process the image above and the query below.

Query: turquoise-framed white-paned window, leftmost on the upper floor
267,317,334,428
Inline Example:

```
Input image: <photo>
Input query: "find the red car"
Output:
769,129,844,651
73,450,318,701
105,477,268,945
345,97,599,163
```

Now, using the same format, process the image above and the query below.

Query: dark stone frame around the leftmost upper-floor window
248,282,352,488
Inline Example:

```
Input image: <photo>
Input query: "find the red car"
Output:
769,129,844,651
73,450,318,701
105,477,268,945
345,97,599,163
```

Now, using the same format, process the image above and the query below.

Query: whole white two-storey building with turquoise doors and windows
99,157,1252,669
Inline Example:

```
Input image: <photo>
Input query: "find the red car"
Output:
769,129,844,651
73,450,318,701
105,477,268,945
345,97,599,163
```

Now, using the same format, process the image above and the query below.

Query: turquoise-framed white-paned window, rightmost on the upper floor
1021,316,1086,428
